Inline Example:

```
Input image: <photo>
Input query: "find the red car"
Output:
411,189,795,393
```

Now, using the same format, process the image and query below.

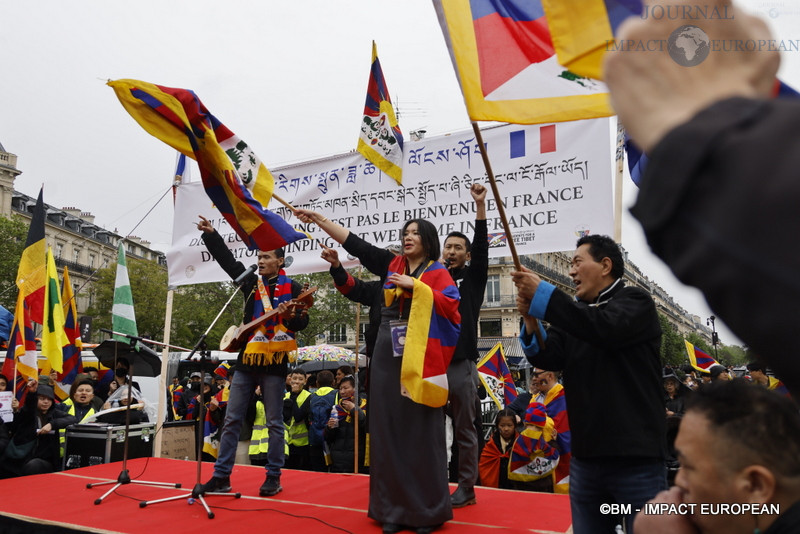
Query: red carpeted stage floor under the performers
0,458,571,534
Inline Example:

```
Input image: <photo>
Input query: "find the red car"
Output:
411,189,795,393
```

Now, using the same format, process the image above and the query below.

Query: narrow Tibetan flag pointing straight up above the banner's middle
358,41,403,184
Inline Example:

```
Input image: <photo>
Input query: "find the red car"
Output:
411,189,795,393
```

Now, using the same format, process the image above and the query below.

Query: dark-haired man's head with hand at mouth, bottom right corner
635,379,800,534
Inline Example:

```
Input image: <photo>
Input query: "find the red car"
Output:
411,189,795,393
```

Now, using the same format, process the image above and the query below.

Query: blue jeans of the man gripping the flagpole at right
569,457,667,534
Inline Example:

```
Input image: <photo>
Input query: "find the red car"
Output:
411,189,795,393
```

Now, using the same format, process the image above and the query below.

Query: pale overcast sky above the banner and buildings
0,0,800,343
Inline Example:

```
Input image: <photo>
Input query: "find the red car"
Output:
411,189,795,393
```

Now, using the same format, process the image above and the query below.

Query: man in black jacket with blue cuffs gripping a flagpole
511,235,666,534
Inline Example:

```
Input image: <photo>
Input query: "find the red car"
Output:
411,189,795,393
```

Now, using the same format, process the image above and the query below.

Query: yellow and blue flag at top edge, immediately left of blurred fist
542,0,642,80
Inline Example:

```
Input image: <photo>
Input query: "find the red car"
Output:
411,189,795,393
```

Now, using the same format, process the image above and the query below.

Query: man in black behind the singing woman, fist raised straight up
442,183,489,508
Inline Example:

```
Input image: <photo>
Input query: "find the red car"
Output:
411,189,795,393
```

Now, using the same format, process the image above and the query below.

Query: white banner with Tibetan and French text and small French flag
167,119,614,285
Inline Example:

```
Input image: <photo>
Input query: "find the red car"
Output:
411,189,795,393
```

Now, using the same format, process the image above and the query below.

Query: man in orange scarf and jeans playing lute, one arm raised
197,216,308,497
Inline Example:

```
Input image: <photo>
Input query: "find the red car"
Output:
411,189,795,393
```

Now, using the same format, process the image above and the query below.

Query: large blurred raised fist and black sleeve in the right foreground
604,0,800,398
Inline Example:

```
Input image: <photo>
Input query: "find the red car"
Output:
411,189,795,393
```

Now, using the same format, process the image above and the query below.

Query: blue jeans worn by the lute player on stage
214,369,286,478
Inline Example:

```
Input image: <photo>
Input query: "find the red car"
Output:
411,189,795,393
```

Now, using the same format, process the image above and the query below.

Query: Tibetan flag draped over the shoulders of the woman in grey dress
384,256,461,408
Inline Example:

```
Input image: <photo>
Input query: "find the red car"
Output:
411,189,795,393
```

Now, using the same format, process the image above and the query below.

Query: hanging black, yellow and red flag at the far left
17,188,47,324
